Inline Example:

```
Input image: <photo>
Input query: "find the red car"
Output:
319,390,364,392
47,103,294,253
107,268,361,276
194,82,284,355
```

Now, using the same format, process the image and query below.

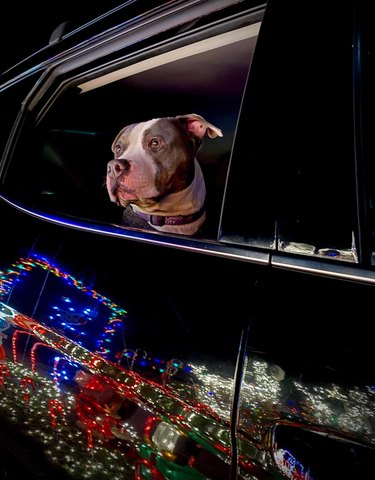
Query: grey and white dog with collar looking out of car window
106,113,223,236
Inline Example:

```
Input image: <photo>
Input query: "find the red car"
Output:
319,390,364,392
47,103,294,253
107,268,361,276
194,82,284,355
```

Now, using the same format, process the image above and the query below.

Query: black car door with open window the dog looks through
0,1,269,479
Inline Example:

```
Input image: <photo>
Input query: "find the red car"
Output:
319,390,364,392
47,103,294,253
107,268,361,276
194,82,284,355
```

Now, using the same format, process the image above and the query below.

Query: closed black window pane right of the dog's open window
221,2,357,261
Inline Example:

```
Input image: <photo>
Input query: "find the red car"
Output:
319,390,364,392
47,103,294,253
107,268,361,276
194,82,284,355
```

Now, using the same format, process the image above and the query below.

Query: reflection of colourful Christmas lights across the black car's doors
0,255,375,480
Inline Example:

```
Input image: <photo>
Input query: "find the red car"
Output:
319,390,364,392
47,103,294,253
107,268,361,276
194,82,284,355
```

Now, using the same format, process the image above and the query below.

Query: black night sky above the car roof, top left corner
0,0,125,74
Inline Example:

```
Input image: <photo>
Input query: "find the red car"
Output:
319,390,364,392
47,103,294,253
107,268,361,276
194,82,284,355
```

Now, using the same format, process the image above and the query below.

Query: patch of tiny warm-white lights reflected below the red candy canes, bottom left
0,363,132,480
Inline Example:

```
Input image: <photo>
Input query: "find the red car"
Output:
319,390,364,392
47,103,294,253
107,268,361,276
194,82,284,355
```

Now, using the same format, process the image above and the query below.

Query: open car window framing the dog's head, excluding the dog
1,13,260,240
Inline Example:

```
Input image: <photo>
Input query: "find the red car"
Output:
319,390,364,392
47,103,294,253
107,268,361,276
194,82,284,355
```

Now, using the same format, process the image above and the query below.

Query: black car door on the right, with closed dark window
221,2,374,479
